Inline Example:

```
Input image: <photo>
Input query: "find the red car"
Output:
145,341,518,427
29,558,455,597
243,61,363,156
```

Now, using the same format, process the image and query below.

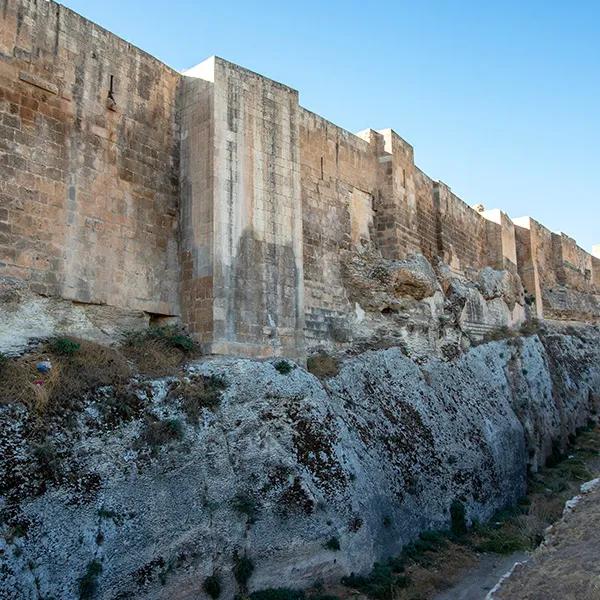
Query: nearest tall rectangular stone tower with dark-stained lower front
182,57,304,356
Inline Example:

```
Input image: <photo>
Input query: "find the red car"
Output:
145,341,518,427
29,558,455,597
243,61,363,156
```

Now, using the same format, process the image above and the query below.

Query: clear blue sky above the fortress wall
63,0,600,250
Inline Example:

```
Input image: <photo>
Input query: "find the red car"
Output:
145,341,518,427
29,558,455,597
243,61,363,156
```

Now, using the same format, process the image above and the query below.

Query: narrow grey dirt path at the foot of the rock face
433,552,529,600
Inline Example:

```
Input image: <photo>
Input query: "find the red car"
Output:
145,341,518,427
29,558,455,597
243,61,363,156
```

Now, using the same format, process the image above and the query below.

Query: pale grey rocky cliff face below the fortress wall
0,328,600,600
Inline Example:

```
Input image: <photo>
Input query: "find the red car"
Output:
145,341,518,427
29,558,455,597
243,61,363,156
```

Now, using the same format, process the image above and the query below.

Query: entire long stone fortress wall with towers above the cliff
0,0,600,356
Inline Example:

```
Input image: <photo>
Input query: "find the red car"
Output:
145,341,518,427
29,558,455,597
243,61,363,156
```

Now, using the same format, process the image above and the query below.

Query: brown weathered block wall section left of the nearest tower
0,0,180,315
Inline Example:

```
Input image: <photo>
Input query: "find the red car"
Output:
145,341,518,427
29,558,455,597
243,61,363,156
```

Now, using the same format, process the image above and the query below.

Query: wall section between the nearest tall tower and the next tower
300,109,378,341
